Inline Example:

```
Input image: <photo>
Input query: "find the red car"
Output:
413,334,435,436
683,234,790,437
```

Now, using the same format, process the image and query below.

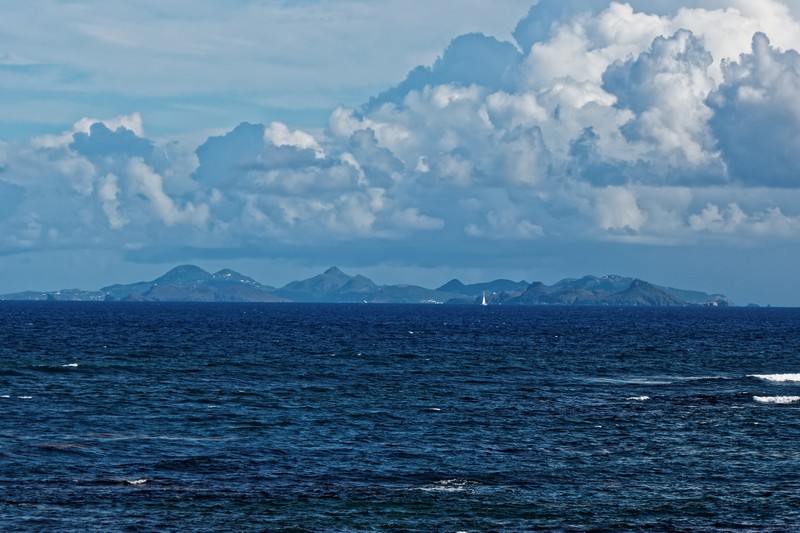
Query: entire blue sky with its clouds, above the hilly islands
0,0,800,306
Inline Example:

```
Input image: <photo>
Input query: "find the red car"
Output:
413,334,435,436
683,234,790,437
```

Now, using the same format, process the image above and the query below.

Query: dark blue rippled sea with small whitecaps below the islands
0,302,800,532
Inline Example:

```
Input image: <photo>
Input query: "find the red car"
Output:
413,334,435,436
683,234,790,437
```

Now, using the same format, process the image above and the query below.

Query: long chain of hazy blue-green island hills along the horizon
0,265,733,307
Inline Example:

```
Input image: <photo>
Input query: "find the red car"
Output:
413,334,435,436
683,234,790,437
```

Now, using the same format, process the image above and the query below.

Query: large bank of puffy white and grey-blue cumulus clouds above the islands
0,0,800,300
